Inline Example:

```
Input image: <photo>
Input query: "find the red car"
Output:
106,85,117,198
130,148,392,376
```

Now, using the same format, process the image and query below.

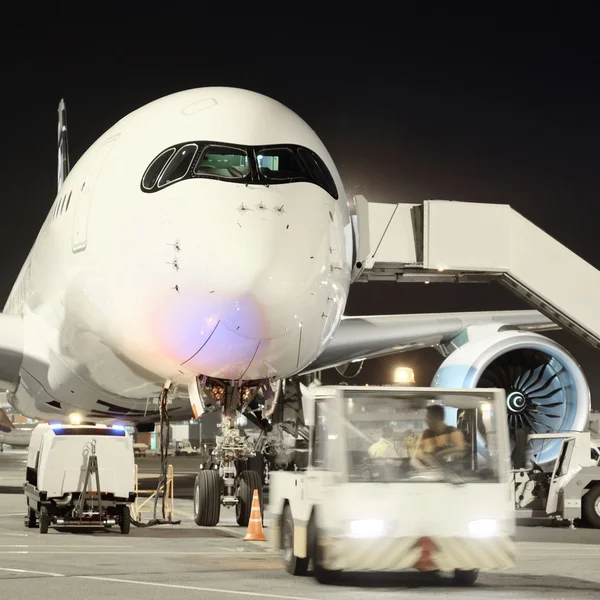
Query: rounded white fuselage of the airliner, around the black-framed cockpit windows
4,88,352,420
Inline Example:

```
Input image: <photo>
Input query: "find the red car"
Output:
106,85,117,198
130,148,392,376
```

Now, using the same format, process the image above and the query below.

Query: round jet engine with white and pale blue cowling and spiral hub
432,327,590,464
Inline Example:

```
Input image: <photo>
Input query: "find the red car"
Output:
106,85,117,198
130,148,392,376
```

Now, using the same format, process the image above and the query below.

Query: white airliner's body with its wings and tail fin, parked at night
0,87,584,524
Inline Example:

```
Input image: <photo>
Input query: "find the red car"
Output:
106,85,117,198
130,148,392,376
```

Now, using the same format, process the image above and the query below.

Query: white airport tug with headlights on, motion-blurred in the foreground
266,386,516,585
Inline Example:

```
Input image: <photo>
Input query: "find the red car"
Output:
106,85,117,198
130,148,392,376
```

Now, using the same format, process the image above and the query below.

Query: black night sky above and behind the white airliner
0,9,600,400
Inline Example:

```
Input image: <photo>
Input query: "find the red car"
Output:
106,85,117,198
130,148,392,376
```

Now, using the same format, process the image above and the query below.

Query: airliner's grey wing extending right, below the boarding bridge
301,310,560,374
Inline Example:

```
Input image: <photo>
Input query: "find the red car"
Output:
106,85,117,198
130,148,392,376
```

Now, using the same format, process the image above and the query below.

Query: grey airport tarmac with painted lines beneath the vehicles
0,452,600,600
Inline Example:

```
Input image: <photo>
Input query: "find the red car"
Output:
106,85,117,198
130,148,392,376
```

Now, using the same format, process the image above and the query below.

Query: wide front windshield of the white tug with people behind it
343,393,500,484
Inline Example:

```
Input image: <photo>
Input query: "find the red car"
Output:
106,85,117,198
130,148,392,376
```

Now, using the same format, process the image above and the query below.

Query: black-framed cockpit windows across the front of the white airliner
141,142,339,200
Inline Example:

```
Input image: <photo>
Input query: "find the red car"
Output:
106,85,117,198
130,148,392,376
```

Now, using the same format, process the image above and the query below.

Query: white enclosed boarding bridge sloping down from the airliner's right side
353,196,600,349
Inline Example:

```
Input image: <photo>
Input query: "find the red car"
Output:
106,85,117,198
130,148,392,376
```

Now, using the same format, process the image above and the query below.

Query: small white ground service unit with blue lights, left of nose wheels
23,423,135,534
